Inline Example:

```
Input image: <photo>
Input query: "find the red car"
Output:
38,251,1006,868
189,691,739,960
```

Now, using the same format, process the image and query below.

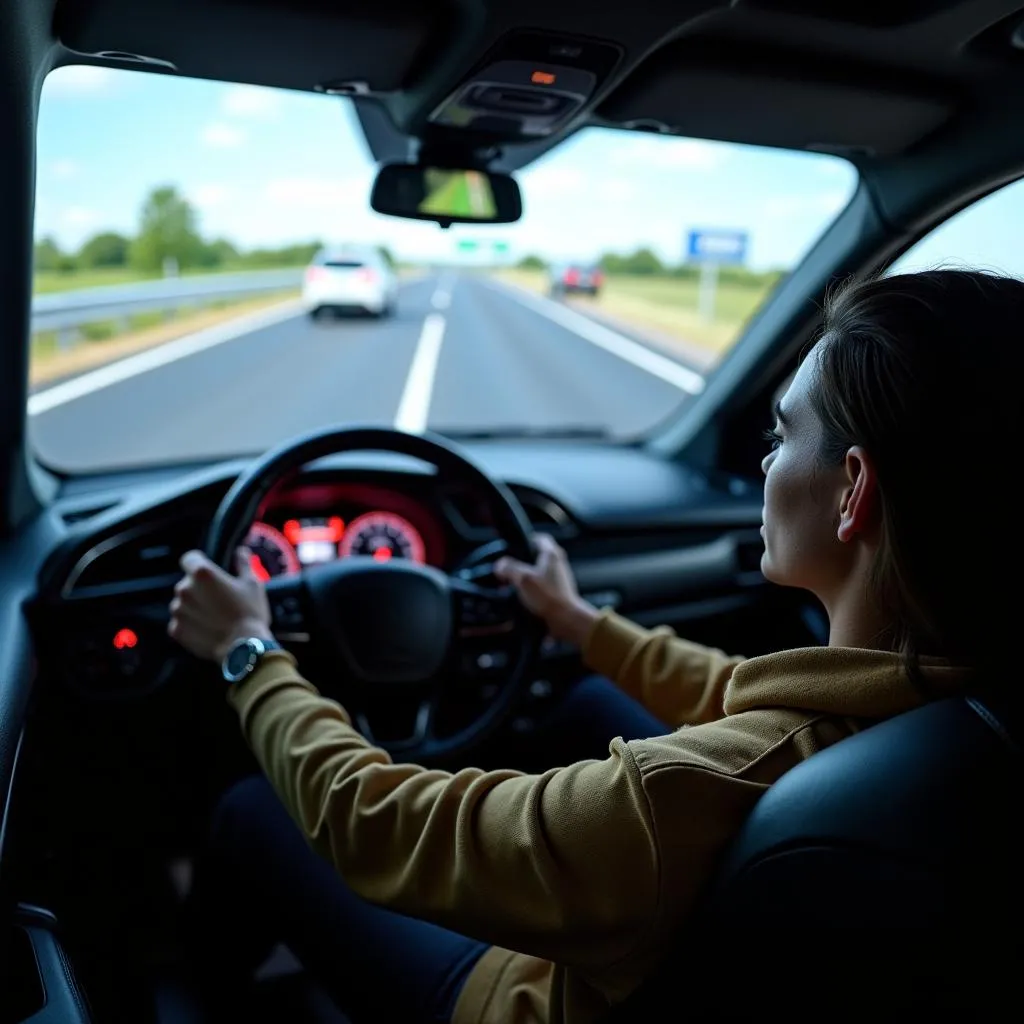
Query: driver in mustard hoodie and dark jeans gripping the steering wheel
170,271,1024,1024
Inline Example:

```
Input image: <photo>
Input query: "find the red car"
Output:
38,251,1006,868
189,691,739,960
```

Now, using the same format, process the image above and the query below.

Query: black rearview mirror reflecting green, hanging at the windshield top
370,164,522,227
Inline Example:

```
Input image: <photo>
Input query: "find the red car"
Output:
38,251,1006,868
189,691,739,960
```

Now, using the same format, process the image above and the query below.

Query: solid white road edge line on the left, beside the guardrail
28,299,302,416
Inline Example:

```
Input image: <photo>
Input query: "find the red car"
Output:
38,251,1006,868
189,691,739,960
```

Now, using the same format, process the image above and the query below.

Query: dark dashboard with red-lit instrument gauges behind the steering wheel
30,443,800,703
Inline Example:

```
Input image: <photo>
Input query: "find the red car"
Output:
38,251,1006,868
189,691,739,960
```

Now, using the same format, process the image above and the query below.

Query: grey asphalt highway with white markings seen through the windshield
29,271,703,470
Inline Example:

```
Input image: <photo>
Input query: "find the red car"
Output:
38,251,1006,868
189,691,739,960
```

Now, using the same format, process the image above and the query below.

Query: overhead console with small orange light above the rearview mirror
428,32,623,141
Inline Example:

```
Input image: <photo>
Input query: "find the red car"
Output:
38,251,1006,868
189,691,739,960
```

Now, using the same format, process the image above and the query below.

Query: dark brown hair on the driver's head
811,270,1024,683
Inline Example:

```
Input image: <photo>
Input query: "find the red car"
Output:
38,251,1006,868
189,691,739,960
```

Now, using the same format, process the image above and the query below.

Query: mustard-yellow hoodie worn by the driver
229,612,963,1024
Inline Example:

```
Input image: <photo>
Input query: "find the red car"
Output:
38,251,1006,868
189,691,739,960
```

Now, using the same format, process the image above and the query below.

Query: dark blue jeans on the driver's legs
193,677,668,1024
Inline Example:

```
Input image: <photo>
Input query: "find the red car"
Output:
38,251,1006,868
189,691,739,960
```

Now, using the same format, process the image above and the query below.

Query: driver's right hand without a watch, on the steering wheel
495,534,598,646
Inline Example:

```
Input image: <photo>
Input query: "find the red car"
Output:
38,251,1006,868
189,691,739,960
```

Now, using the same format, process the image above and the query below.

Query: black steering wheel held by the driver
206,427,543,761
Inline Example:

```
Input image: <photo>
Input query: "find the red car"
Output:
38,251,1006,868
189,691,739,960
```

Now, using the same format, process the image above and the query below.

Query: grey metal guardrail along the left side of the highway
32,267,304,336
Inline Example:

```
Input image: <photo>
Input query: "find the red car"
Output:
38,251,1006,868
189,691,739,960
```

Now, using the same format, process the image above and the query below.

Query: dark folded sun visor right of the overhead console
598,47,955,157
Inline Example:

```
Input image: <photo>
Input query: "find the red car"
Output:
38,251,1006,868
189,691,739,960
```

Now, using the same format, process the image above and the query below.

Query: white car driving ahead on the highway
302,247,398,317
